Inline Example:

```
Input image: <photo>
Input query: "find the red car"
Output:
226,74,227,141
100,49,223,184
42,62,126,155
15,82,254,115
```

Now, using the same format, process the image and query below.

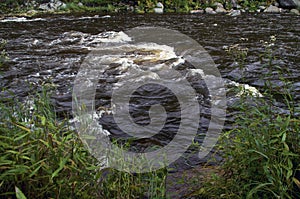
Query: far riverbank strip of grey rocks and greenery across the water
0,0,300,19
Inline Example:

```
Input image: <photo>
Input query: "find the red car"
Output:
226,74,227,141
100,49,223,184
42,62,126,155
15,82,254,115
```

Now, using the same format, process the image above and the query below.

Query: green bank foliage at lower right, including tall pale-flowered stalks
201,36,300,199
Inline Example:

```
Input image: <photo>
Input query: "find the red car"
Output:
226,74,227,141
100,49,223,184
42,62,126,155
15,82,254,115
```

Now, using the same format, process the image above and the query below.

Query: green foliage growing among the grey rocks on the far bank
0,0,274,13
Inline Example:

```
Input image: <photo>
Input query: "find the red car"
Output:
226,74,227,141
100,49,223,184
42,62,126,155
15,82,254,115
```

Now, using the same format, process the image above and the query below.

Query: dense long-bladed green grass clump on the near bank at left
0,87,101,198
